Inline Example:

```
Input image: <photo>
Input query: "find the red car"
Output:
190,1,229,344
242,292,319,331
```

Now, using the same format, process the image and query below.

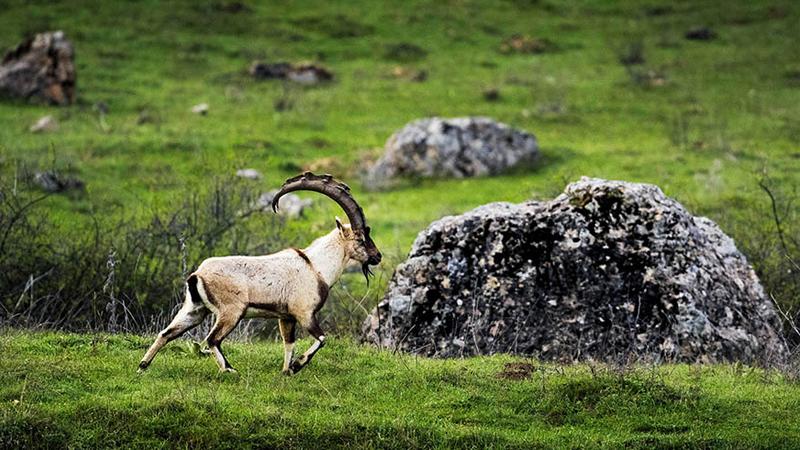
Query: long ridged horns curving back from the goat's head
272,172,368,231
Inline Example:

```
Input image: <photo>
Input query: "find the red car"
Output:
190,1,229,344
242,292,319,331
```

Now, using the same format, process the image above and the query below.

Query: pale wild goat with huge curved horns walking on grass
139,172,381,375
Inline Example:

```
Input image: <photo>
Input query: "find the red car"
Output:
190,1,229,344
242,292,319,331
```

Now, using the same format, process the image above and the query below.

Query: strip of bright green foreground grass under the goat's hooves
0,332,800,449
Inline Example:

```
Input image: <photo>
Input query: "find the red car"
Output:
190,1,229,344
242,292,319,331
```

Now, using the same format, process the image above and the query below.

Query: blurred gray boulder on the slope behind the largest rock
364,117,539,189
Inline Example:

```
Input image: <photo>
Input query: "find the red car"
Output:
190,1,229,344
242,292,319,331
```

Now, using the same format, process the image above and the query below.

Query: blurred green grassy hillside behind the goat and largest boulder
0,1,800,250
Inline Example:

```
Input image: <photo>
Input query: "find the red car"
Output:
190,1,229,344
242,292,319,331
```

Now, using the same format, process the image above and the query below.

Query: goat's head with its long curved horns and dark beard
272,172,381,283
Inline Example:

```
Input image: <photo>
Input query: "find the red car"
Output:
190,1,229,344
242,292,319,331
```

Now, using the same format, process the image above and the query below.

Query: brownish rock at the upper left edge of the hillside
0,31,76,105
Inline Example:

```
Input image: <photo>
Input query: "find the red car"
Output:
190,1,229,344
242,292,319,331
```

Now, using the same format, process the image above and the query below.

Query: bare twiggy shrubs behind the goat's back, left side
0,172,286,332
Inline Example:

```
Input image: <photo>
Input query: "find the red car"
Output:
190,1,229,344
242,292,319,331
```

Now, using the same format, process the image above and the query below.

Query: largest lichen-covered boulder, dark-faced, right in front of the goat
363,178,788,362
